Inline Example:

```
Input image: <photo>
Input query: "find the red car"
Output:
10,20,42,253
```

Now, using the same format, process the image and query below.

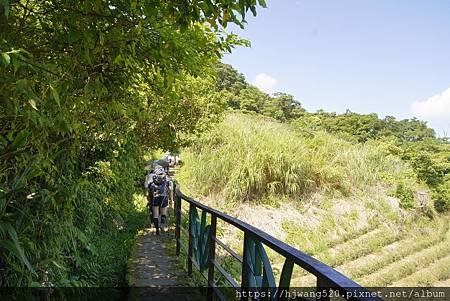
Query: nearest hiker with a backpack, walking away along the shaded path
146,166,169,235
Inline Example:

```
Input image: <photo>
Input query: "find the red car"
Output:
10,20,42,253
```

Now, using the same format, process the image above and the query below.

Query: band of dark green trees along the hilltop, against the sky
211,64,450,212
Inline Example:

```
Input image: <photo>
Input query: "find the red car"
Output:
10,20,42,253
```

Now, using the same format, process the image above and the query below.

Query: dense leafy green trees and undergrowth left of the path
0,0,265,286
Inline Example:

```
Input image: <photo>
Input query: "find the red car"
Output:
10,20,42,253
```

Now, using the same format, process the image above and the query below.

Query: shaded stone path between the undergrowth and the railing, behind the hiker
127,228,201,301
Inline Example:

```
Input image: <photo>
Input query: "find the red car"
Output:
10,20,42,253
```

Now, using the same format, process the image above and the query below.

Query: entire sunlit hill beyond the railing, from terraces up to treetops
177,64,450,286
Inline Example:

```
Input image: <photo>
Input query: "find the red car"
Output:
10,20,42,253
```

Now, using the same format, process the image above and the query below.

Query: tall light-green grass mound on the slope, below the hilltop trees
178,113,415,200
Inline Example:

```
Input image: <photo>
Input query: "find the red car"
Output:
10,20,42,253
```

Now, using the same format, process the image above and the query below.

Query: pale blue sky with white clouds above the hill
223,0,450,136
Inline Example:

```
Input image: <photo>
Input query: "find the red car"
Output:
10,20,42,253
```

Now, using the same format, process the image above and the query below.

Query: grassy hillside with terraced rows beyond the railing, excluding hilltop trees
178,113,450,286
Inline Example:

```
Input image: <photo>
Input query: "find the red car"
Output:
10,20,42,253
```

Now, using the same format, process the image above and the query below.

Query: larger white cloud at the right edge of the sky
410,88,450,119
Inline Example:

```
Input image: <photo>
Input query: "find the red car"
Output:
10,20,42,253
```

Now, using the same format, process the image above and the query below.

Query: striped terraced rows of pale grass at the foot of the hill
293,217,450,286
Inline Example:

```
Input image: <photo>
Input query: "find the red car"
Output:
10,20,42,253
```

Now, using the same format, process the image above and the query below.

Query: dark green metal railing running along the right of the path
173,181,381,300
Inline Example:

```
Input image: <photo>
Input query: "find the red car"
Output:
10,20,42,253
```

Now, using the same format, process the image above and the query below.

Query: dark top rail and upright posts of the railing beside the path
173,181,381,300
